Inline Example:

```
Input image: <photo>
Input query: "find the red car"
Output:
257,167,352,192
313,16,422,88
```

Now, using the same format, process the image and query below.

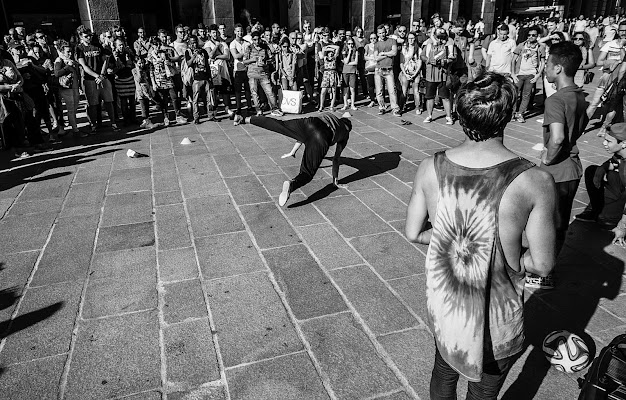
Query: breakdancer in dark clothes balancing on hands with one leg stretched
234,113,352,207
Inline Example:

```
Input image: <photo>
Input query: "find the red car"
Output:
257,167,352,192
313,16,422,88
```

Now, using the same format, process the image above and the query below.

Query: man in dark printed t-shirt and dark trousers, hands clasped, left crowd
76,25,119,134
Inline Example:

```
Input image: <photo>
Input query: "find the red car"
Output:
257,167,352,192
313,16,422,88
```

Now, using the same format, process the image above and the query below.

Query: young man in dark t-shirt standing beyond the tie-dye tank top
526,42,589,289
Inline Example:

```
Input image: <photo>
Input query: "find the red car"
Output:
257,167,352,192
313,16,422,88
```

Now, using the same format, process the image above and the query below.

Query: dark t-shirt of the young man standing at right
539,85,589,183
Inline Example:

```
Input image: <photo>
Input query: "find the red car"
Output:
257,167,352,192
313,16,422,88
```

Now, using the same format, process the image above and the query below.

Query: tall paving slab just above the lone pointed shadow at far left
31,215,98,285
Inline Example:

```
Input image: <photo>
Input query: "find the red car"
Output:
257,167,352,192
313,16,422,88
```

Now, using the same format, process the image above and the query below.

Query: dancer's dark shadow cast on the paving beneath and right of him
287,151,402,208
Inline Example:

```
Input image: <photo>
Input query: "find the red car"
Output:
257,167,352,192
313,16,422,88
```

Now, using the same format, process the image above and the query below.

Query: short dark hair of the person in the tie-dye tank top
456,72,517,142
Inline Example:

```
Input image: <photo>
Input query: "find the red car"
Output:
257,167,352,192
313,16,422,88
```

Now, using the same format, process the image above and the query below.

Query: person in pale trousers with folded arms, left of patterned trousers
374,25,402,117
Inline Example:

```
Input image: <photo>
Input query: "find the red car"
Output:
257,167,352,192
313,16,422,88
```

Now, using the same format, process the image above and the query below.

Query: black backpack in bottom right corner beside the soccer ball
578,334,626,400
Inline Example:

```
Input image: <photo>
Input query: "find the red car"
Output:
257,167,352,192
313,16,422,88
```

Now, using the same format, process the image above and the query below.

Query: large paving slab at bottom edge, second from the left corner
65,311,161,400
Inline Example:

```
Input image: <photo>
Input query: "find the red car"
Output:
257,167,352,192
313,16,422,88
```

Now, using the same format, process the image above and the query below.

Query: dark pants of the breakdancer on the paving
250,116,333,192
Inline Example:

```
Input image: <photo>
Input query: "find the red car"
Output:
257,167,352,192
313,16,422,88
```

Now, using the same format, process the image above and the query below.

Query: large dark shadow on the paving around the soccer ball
502,221,624,400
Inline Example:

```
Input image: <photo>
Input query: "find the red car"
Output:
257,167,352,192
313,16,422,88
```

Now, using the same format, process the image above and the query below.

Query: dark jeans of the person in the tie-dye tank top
430,349,517,400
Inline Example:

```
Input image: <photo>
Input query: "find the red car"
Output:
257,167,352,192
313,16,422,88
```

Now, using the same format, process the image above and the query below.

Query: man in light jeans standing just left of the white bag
243,31,283,117
